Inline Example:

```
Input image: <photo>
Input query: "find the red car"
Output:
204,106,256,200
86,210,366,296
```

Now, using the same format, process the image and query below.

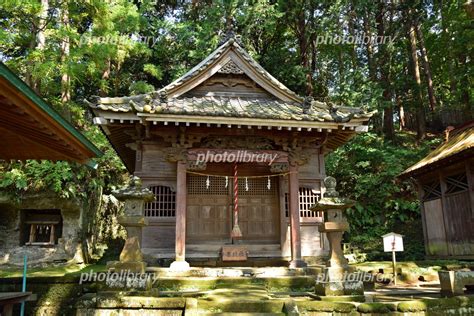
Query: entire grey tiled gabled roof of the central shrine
88,37,373,126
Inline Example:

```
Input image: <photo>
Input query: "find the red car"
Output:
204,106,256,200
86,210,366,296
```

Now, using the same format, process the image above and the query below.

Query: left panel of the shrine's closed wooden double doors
186,175,231,244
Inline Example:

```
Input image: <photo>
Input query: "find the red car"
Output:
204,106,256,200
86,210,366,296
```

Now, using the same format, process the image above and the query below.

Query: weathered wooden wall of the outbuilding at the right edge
418,159,474,258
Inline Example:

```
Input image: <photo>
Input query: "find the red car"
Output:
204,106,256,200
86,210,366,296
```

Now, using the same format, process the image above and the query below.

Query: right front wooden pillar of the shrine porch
288,164,306,268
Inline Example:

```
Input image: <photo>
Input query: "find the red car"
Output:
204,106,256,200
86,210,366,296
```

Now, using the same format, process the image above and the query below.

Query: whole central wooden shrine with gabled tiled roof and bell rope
88,35,372,266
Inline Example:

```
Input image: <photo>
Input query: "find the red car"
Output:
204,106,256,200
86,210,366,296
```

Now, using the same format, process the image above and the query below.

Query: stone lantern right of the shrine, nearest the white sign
311,177,364,296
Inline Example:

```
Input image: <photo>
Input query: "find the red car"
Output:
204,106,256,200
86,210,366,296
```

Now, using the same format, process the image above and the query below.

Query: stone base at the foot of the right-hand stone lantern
315,267,364,296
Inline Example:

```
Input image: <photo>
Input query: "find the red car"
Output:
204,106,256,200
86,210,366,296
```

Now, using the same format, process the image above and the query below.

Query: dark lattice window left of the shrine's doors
145,185,176,217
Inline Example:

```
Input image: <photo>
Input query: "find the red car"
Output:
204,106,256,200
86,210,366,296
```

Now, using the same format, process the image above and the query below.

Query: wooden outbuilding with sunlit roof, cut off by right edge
401,121,474,259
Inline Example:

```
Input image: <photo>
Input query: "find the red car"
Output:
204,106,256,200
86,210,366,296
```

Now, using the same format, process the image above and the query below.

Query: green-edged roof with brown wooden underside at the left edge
0,62,102,163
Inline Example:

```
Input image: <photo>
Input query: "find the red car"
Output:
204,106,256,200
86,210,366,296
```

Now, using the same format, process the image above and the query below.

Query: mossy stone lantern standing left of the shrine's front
107,176,155,273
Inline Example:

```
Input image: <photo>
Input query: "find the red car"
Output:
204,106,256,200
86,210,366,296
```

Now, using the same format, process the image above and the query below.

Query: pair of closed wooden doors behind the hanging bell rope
186,175,280,244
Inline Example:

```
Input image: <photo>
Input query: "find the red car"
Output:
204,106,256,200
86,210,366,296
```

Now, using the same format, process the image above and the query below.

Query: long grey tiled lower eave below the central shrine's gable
91,95,373,122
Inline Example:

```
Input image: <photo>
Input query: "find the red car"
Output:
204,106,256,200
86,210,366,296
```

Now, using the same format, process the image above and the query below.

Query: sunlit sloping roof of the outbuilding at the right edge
401,121,474,177
